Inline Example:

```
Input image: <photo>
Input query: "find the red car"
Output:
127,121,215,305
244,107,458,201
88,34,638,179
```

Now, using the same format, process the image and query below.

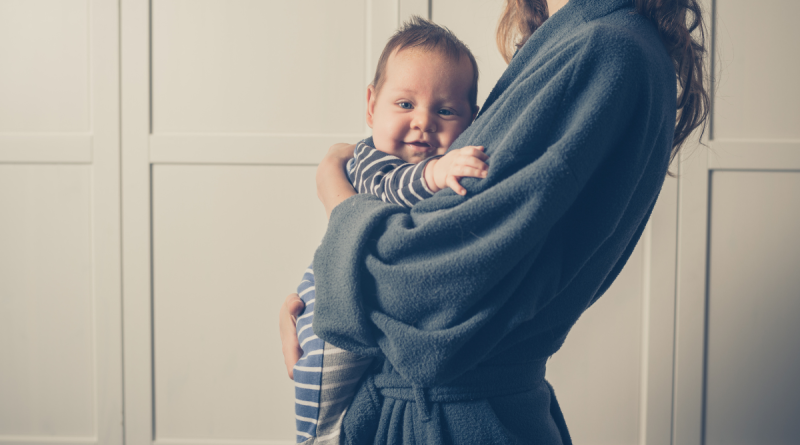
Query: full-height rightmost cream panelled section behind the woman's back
673,1,800,445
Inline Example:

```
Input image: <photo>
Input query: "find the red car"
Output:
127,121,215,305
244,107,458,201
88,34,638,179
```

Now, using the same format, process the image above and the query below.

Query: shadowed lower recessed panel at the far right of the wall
704,172,800,445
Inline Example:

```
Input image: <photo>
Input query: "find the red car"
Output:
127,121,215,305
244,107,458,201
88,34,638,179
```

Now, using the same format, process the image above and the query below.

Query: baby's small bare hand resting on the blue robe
424,146,489,195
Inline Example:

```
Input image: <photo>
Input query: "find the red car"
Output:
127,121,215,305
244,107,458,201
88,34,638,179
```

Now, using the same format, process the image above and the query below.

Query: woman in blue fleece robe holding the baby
280,0,708,438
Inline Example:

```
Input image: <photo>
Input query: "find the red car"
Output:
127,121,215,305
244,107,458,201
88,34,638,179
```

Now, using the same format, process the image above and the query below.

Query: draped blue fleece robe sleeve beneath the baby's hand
314,28,656,386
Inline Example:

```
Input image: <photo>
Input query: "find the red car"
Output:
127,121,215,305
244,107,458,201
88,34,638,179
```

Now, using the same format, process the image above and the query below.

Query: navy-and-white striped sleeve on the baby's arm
350,141,441,207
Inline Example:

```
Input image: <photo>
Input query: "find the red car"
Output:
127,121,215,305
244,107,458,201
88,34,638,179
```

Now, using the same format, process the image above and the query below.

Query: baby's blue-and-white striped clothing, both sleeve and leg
294,140,433,445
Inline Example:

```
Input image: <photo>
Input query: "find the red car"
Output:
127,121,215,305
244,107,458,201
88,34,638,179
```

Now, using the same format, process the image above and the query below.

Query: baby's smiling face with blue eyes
367,49,475,163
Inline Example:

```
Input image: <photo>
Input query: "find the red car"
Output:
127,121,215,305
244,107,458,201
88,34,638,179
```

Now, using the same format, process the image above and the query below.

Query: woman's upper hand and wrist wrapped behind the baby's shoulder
317,144,356,218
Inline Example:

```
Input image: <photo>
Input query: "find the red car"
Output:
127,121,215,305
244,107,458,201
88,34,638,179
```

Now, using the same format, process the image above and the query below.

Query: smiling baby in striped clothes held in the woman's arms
294,17,488,444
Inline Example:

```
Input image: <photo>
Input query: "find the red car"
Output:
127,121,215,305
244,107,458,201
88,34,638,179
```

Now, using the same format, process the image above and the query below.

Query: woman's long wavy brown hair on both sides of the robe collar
497,0,710,162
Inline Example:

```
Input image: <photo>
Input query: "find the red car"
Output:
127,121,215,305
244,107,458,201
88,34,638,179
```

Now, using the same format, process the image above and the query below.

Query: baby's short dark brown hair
372,15,478,111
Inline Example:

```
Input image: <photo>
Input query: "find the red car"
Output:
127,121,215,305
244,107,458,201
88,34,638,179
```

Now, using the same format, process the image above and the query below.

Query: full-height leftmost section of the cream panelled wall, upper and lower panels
0,0,123,444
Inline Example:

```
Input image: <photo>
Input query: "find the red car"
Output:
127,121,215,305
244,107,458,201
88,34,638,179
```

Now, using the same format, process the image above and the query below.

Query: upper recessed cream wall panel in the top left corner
0,0,91,133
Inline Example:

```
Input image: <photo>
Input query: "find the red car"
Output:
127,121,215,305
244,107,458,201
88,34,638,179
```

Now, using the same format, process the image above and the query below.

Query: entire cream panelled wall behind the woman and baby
0,0,800,445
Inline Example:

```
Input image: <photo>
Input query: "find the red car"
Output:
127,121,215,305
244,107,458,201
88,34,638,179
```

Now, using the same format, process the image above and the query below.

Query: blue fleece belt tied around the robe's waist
371,358,547,422
